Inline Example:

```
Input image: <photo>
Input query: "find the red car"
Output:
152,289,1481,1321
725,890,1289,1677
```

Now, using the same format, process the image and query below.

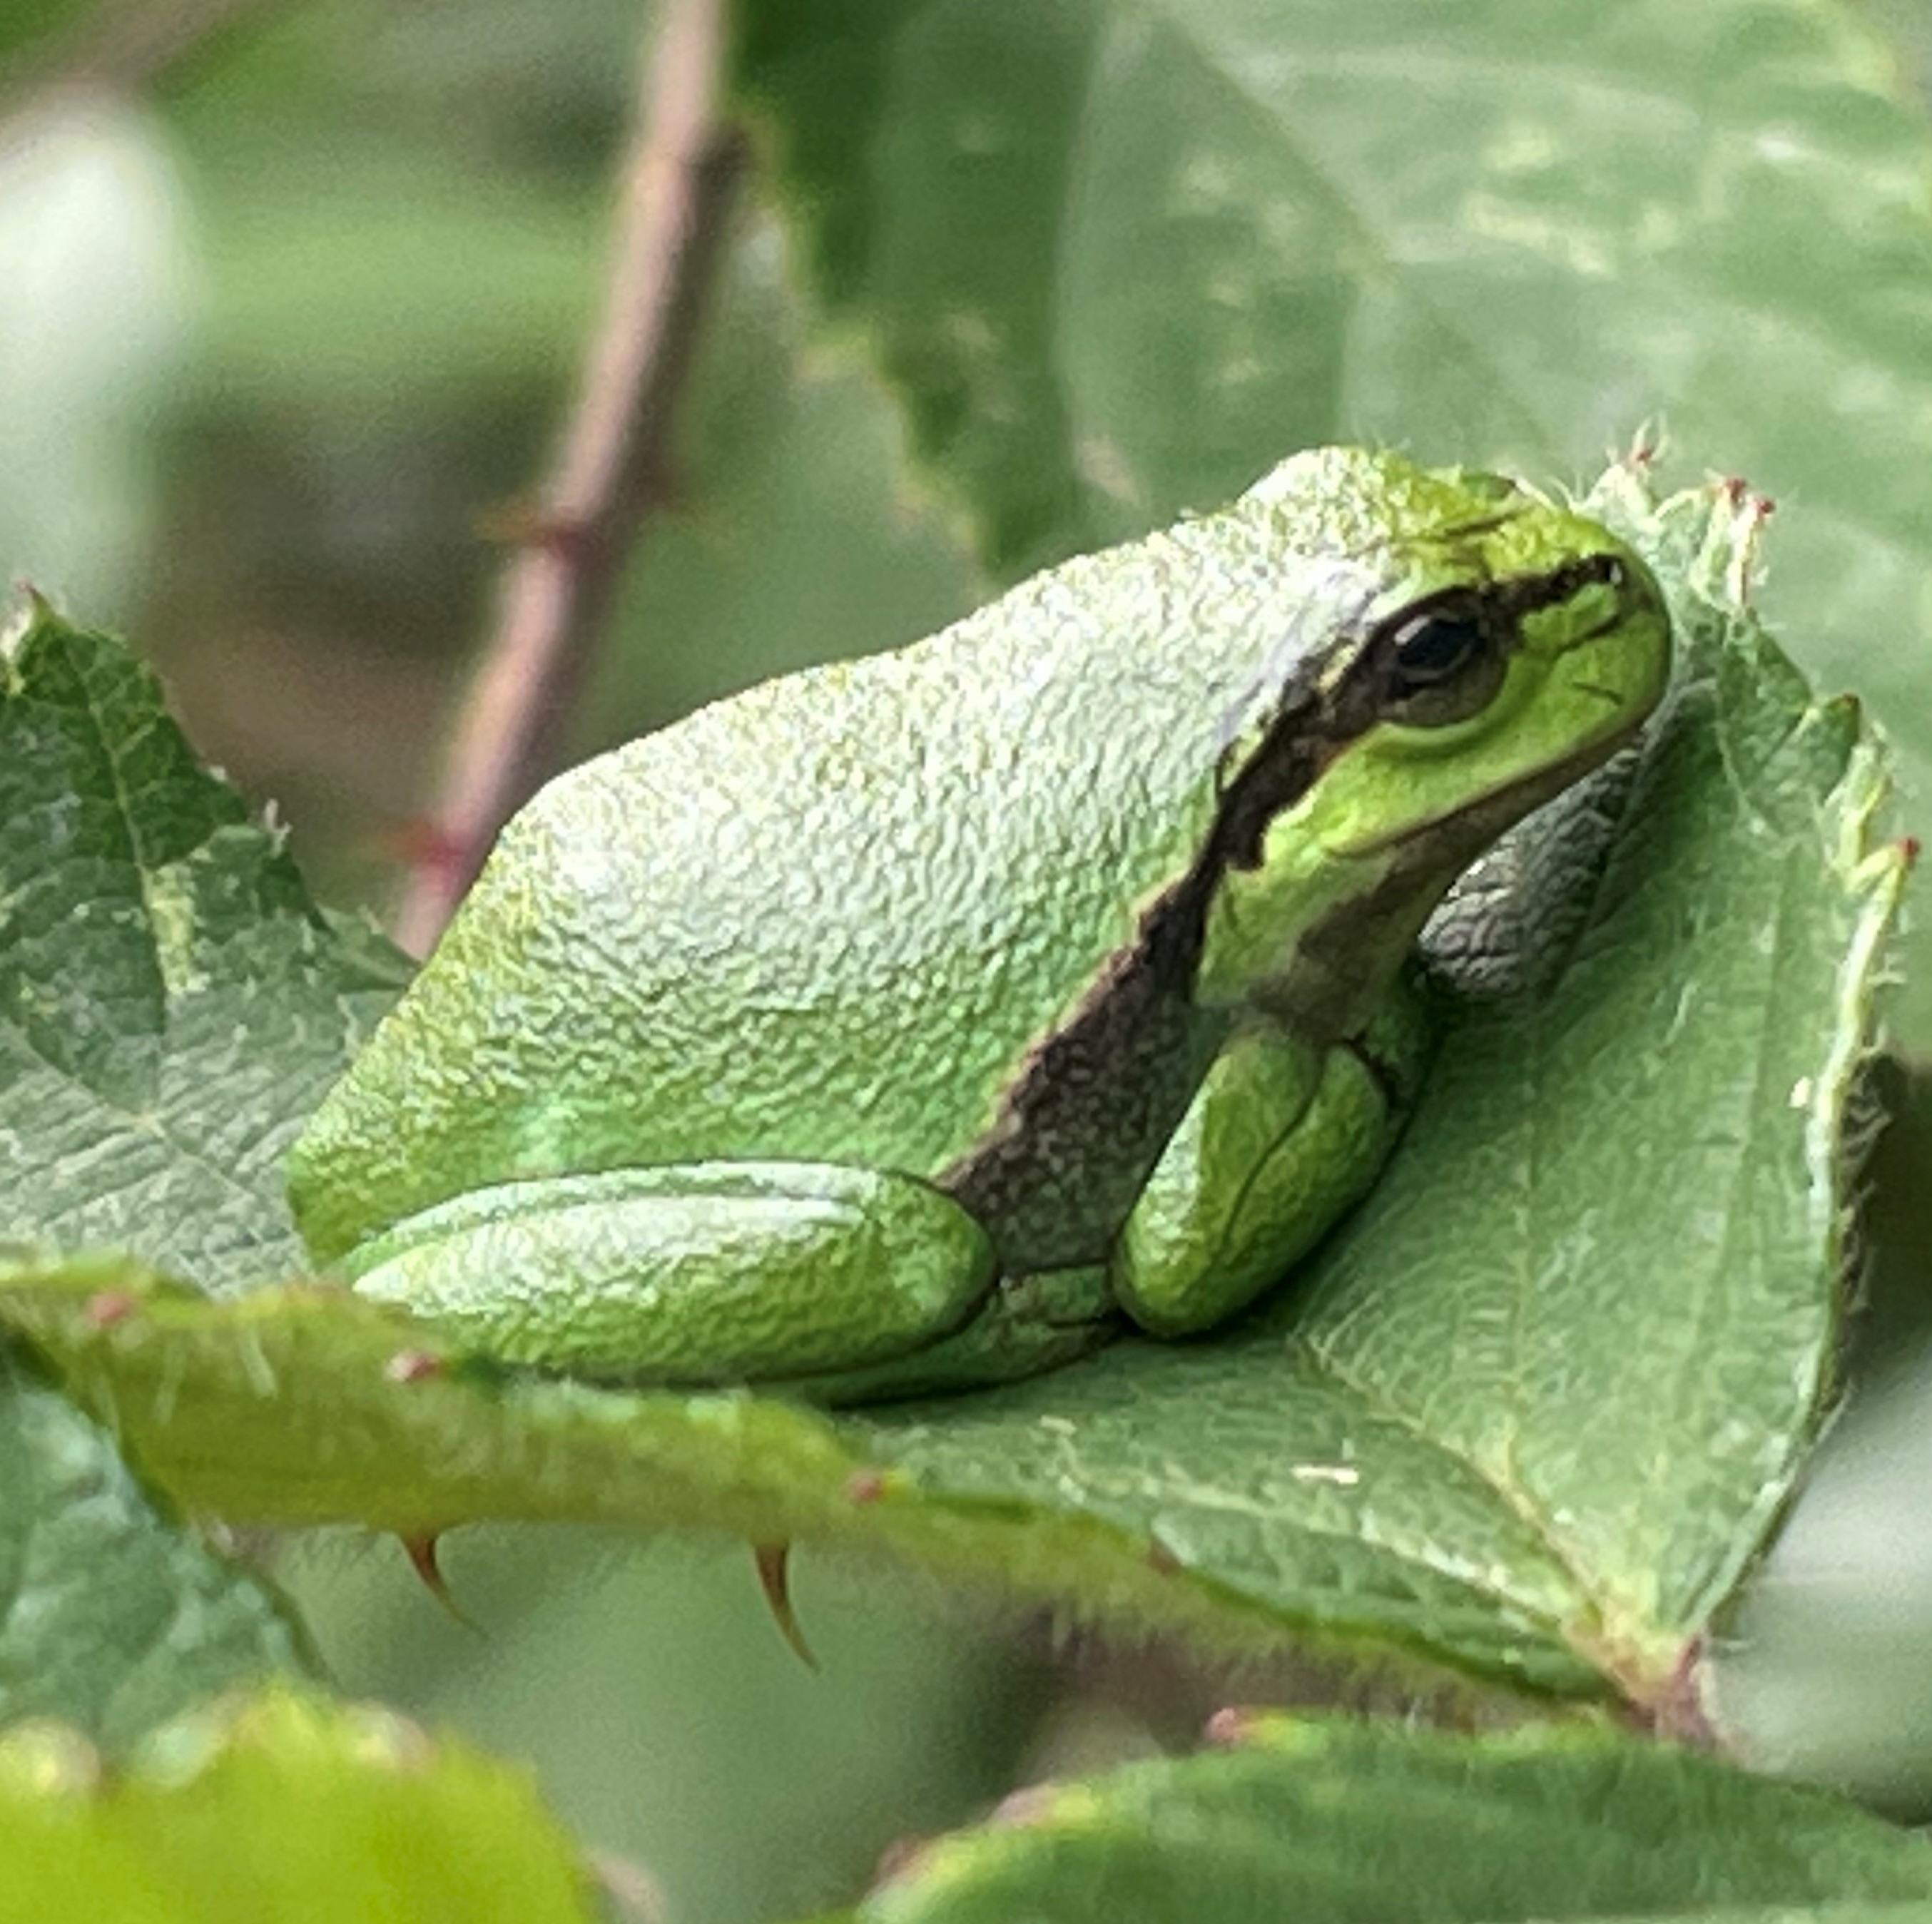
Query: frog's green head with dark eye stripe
1198,450,1671,1026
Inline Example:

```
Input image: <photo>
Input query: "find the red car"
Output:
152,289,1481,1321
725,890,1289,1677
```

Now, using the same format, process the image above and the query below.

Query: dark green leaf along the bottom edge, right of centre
823,1717,1932,1924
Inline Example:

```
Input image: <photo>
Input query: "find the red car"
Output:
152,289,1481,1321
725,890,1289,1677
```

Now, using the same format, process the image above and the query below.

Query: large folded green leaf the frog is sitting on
0,469,1905,1699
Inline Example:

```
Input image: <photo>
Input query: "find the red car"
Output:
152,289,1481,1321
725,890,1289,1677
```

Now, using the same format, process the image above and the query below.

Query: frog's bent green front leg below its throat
1111,979,1430,1337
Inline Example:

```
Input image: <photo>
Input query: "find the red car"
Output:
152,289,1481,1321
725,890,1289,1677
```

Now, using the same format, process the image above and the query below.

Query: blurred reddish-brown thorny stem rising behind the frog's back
396,0,744,952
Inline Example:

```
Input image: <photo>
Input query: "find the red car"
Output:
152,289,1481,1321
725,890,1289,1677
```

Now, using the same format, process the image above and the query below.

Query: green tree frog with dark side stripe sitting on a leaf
292,448,1669,1400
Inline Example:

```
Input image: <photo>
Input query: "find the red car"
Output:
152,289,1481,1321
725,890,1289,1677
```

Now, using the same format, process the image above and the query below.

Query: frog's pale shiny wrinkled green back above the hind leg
298,452,1422,1248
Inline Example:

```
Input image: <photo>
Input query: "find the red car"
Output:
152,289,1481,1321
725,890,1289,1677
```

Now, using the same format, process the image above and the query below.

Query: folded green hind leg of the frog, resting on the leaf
344,1163,997,1383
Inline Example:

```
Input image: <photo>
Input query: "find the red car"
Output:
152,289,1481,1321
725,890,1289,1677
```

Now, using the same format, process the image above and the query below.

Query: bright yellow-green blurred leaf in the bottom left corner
0,1694,603,1924
